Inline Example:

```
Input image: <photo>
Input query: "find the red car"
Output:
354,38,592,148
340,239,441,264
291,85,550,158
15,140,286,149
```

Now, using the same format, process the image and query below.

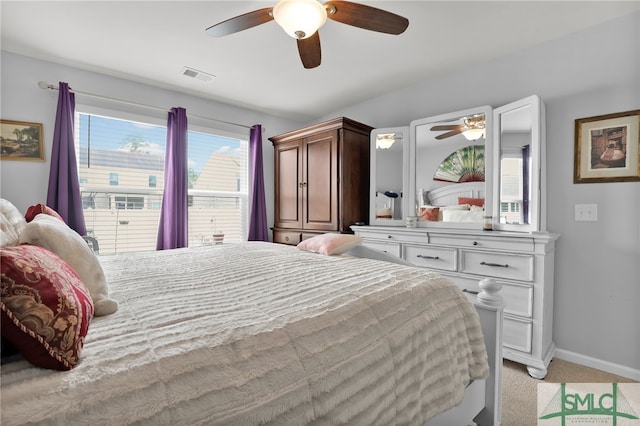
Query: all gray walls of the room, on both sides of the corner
0,9,640,379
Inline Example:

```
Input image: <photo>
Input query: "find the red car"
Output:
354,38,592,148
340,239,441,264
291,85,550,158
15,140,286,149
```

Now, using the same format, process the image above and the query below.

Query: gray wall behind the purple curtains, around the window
0,51,301,231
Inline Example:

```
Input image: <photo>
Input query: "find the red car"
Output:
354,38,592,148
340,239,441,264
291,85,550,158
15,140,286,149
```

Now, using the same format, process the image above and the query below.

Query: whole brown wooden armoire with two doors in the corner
269,117,373,245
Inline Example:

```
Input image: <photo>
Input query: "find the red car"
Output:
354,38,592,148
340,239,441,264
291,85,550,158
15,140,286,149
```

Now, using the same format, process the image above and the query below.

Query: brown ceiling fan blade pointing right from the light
324,0,409,35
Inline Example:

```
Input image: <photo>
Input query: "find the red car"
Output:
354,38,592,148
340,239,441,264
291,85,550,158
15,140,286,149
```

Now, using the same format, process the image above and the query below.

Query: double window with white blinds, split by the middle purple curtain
75,108,248,255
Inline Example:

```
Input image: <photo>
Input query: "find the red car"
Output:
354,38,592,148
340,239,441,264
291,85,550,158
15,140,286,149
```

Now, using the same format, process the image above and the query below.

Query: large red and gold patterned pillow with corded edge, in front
0,245,93,370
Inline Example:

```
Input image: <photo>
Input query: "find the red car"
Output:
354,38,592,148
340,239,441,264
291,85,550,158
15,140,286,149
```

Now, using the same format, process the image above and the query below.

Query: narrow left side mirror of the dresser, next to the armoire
369,126,409,226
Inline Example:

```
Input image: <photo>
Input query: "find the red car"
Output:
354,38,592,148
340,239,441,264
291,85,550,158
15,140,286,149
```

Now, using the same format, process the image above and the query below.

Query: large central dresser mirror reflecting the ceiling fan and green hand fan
408,106,493,229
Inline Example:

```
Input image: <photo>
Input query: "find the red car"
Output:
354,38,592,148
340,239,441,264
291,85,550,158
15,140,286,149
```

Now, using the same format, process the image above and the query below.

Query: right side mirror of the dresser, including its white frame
493,96,546,231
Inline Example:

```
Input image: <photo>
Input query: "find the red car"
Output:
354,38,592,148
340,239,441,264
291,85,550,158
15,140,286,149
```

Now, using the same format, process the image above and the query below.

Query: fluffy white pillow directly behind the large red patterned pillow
20,213,118,316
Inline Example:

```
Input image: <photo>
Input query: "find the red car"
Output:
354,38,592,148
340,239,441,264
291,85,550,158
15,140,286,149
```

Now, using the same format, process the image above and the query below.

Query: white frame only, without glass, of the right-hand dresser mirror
491,95,547,232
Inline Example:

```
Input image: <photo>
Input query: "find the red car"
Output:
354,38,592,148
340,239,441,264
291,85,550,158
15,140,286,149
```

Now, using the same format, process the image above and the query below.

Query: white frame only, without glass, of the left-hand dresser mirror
369,126,411,226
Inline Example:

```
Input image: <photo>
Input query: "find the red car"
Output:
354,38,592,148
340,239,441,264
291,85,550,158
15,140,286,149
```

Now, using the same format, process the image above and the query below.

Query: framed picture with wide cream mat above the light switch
573,110,640,183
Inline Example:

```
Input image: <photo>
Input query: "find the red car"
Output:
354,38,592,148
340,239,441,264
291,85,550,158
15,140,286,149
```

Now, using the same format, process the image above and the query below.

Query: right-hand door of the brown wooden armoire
302,131,339,231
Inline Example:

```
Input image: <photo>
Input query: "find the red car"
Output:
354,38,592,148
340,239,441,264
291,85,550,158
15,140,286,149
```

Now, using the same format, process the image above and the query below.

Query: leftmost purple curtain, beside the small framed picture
47,82,87,235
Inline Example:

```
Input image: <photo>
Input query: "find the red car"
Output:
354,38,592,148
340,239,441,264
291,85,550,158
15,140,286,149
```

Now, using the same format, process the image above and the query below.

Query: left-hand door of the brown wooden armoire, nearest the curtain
274,140,303,229
